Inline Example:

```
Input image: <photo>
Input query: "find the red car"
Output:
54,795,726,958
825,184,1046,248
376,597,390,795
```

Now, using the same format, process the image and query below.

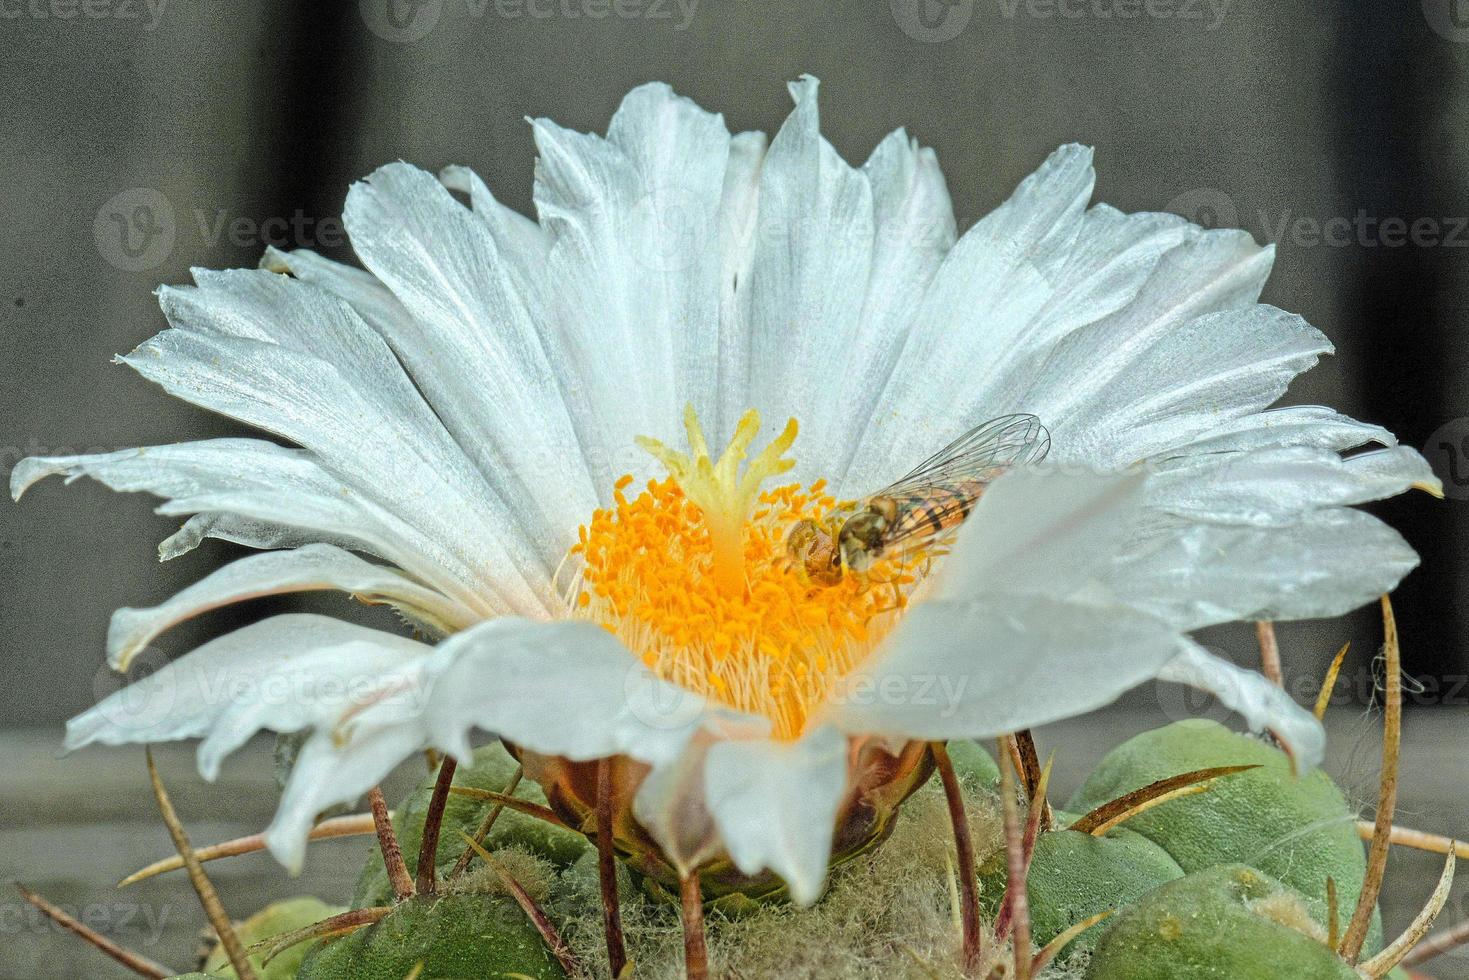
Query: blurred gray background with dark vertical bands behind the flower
0,0,1469,977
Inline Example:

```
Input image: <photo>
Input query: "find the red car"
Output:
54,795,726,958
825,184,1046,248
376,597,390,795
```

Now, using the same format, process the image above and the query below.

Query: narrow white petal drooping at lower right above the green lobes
1158,641,1327,768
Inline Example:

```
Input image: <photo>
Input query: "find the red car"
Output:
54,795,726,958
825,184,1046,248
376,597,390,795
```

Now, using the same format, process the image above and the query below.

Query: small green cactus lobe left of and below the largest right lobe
980,811,1183,958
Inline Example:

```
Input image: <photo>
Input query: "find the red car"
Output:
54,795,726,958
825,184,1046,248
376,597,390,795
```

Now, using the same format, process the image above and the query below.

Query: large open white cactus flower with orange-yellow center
22,78,1437,902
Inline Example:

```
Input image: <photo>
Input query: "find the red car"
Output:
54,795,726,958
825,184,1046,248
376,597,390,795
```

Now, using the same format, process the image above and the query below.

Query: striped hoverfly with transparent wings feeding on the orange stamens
786,414,1050,586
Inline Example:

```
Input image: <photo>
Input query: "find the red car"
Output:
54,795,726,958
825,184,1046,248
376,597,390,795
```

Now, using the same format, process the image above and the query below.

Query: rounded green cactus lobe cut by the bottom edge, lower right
1086,864,1357,980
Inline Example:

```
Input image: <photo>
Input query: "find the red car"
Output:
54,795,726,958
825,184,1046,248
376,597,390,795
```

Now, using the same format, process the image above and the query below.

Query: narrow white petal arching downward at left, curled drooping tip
107,545,477,670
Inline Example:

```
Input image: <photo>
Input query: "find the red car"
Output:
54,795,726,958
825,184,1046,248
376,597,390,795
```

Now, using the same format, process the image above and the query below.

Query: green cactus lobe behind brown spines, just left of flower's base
353,742,591,908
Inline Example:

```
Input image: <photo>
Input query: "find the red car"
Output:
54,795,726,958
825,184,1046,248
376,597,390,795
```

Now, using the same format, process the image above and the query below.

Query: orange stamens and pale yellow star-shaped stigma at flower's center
570,407,925,738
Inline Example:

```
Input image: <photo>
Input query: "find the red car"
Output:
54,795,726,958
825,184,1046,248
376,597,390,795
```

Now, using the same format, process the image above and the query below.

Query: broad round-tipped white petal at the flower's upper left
344,163,599,528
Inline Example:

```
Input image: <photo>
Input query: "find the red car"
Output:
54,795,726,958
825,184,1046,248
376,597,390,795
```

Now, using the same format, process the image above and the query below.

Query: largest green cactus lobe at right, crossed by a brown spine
1068,720,1382,951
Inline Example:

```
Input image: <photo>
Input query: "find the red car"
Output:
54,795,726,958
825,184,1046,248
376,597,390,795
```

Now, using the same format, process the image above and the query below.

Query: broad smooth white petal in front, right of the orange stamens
827,595,1178,739
